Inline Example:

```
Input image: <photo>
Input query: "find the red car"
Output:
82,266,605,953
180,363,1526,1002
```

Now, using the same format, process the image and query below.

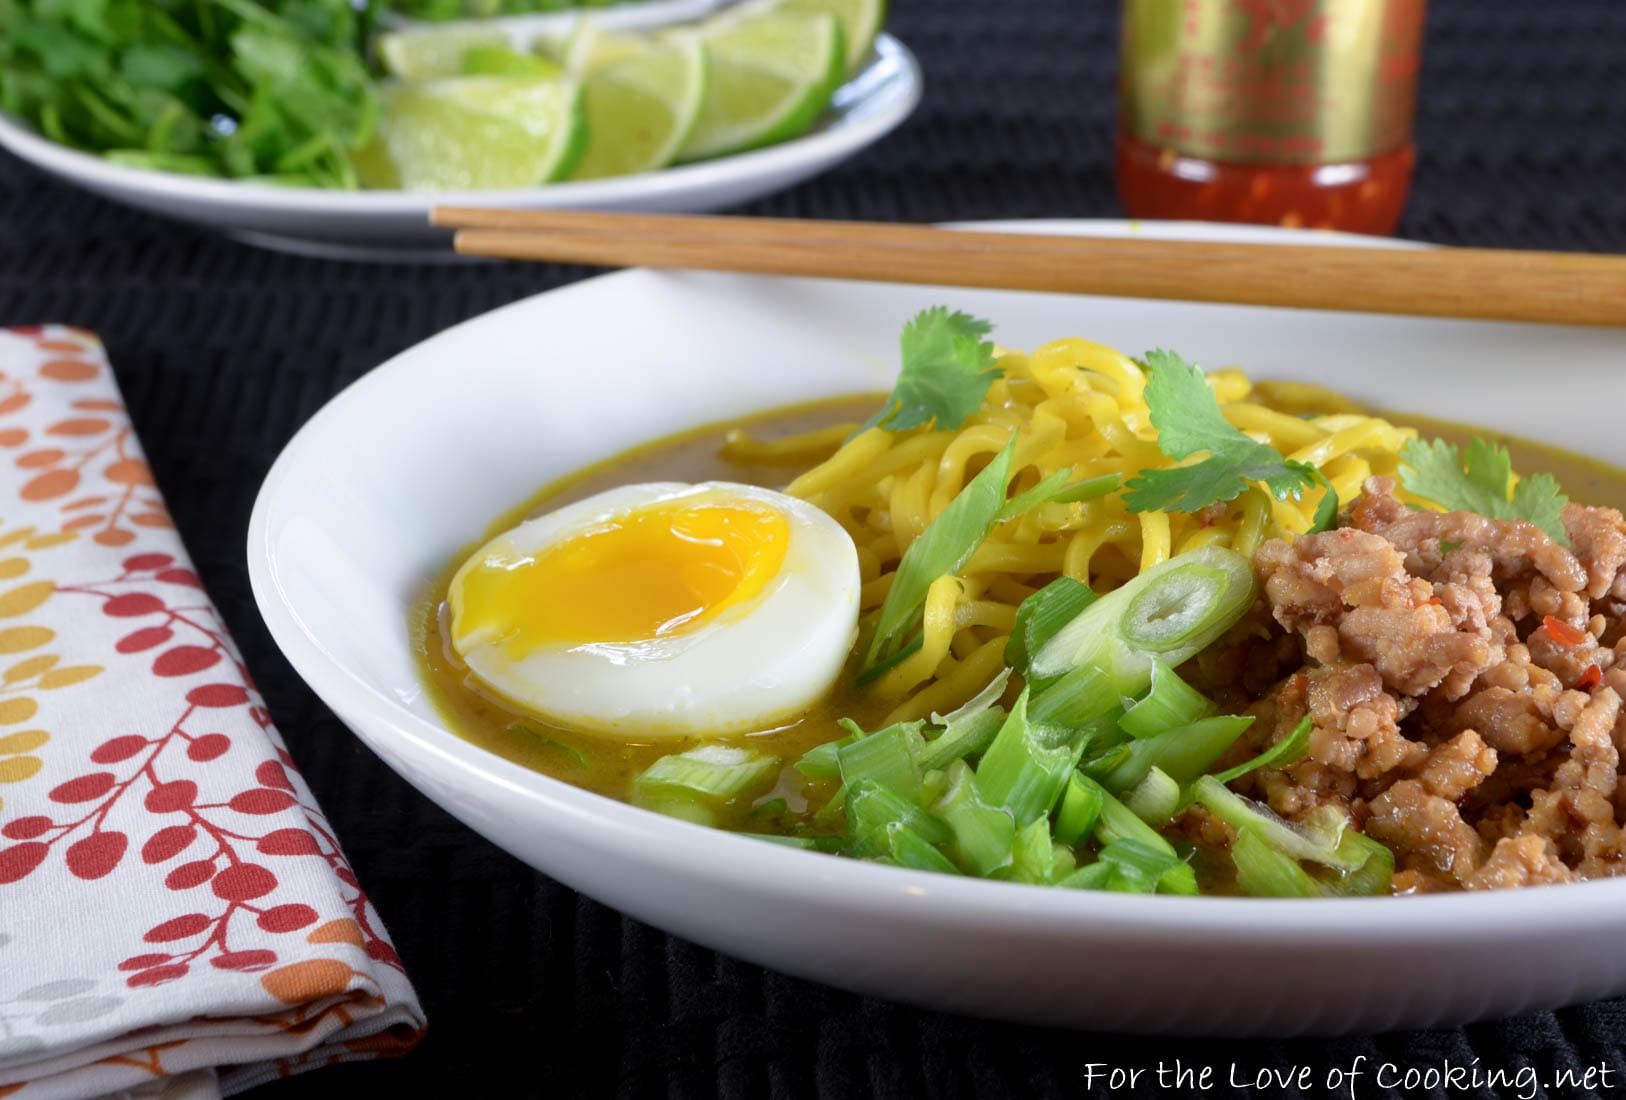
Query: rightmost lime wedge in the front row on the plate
678,13,846,161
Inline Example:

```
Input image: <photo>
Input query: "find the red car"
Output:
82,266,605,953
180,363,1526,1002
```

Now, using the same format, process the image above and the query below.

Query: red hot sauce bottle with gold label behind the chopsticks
1117,0,1424,234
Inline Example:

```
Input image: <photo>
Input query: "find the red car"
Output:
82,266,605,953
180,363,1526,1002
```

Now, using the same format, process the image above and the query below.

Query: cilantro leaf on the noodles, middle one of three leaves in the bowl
1124,351,1337,512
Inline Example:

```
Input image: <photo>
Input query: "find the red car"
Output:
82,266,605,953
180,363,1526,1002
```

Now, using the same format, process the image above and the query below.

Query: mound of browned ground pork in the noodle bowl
1205,478,1626,892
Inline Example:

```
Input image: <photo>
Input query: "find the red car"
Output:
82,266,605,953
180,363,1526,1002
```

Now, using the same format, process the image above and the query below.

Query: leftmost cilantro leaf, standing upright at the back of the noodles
865,305,1000,432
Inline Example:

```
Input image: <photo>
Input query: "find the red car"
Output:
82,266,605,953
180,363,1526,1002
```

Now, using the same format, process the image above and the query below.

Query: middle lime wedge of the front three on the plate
571,41,707,179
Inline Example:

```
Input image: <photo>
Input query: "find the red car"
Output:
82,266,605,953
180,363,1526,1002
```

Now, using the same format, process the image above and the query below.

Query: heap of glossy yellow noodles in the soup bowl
725,340,1416,721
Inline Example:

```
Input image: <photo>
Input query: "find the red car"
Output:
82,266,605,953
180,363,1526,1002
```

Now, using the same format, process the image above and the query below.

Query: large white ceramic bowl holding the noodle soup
249,223,1626,1035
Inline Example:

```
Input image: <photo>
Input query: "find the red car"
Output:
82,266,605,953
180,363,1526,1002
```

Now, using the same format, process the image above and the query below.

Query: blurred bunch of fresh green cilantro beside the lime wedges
0,0,379,188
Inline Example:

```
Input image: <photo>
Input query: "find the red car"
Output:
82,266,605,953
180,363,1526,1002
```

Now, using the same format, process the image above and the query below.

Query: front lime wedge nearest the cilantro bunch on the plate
356,76,587,190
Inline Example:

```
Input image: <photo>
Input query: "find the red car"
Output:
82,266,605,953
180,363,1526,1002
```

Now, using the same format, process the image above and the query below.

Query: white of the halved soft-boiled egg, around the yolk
452,481,860,738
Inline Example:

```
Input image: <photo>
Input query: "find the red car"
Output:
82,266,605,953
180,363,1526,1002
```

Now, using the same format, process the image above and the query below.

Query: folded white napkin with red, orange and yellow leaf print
0,327,423,1100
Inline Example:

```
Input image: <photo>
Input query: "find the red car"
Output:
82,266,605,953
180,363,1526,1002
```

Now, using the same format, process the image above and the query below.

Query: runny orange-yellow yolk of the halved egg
452,497,790,660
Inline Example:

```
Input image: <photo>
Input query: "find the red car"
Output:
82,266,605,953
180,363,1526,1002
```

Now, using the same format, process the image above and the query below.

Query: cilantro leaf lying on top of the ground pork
1400,439,1569,546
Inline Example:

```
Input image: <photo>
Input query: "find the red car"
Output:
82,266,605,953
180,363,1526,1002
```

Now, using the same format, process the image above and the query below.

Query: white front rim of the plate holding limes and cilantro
0,34,924,218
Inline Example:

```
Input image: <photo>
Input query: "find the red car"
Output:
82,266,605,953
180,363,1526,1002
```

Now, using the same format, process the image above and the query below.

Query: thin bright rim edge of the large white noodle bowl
247,219,1626,946
